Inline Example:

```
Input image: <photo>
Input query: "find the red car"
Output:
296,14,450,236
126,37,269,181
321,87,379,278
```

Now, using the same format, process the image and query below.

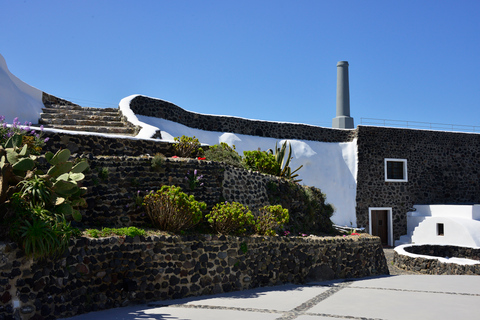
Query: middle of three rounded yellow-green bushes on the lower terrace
205,202,255,235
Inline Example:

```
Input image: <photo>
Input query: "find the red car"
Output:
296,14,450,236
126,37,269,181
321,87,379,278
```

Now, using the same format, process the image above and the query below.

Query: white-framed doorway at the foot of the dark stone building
368,208,393,246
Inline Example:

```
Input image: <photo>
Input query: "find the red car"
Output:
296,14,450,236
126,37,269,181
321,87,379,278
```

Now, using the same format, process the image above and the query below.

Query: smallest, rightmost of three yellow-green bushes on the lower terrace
255,205,290,236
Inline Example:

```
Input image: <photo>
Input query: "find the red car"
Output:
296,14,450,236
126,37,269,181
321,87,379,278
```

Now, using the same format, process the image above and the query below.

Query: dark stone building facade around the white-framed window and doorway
356,126,480,239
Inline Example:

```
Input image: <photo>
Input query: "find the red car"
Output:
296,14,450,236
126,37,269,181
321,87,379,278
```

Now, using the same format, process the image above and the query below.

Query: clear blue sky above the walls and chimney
0,0,480,126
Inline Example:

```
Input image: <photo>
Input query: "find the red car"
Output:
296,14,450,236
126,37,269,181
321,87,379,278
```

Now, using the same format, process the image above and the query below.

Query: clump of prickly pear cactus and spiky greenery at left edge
0,125,88,258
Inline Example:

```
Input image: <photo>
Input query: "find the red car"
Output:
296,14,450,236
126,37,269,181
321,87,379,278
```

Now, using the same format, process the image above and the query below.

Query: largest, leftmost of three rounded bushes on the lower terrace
143,186,207,232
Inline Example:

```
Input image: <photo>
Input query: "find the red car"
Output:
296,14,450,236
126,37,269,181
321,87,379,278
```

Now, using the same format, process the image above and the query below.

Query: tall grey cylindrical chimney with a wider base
332,61,354,129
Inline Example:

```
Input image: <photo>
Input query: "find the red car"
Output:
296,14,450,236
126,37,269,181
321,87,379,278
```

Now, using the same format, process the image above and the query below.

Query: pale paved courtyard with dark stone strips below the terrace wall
63,250,480,320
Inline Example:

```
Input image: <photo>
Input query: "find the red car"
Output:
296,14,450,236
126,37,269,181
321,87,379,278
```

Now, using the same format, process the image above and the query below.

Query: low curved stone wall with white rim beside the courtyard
393,245,480,275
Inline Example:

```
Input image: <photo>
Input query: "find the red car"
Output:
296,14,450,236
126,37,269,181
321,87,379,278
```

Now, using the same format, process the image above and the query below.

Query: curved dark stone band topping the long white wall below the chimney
130,96,356,142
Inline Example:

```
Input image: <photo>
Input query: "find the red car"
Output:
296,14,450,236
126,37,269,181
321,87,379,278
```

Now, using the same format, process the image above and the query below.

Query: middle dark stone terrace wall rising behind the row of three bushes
79,157,274,226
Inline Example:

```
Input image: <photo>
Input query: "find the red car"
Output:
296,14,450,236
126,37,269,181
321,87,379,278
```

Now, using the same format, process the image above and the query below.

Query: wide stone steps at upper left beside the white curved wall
38,101,139,136
